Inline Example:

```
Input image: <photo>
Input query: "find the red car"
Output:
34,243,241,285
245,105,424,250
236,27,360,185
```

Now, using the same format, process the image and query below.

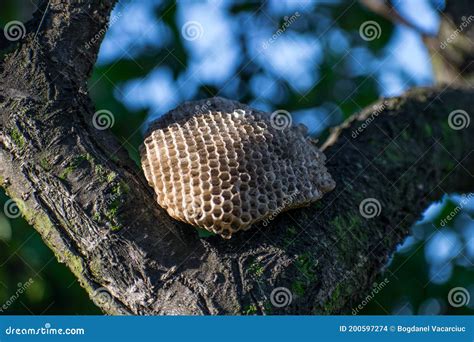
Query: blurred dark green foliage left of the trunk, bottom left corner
0,191,101,315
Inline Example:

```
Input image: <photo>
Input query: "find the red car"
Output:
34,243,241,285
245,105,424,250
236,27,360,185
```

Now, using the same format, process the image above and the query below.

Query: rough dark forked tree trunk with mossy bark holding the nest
0,0,474,314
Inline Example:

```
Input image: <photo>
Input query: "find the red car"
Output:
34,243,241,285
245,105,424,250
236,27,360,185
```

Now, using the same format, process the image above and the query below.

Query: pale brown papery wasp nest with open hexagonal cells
141,98,335,238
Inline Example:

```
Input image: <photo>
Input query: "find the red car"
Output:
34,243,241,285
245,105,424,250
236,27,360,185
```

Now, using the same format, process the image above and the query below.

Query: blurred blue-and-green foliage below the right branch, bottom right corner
362,196,474,315
